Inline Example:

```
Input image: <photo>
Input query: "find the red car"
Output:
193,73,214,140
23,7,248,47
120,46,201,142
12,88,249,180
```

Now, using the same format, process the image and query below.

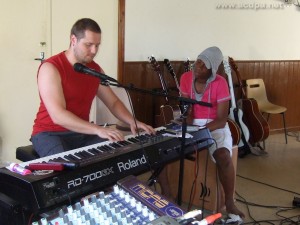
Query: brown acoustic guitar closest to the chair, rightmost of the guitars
229,57,270,146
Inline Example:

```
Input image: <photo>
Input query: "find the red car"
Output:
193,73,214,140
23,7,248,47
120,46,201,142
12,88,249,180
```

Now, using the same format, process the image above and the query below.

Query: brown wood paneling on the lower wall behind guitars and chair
121,60,300,133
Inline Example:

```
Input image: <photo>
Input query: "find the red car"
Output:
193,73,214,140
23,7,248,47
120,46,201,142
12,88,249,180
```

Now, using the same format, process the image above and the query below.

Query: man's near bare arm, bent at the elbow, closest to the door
38,63,123,141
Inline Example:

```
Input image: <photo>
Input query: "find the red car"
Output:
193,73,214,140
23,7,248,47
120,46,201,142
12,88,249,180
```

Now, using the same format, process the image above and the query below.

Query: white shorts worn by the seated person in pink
193,119,232,162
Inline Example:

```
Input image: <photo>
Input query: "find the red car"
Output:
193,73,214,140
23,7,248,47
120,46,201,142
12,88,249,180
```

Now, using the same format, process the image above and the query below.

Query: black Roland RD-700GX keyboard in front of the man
0,127,214,213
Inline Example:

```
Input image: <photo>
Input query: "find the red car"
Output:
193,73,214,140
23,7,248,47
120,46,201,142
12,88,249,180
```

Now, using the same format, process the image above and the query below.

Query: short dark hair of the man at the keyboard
71,18,101,39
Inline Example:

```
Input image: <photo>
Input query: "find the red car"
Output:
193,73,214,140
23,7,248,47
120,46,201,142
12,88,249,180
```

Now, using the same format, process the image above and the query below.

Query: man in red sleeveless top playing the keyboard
31,18,155,157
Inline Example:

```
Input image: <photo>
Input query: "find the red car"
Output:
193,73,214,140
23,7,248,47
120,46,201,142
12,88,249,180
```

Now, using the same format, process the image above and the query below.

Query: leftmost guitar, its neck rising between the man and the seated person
149,56,181,127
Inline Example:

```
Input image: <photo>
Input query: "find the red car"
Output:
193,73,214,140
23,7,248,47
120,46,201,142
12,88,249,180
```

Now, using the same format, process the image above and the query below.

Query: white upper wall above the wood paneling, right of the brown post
125,0,300,61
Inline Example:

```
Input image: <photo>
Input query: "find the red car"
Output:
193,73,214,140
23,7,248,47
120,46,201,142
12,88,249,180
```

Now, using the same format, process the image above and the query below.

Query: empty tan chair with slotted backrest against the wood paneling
246,79,287,144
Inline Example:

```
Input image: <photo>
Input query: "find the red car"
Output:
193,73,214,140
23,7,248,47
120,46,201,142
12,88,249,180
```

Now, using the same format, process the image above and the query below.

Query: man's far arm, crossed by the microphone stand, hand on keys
97,85,155,134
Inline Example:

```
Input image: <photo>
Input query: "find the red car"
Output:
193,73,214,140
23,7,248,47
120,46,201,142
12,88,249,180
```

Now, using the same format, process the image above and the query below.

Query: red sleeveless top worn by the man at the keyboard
32,52,101,136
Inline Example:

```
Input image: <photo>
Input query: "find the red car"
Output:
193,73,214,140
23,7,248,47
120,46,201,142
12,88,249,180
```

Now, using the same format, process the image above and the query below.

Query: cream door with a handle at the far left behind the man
0,0,48,161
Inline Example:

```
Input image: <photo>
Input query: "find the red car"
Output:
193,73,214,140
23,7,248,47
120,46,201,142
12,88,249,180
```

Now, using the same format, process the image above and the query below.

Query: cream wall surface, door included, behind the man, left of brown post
0,0,118,161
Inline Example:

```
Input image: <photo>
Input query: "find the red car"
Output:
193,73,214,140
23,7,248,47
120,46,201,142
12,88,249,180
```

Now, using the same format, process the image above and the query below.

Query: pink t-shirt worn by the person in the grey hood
180,71,231,120
